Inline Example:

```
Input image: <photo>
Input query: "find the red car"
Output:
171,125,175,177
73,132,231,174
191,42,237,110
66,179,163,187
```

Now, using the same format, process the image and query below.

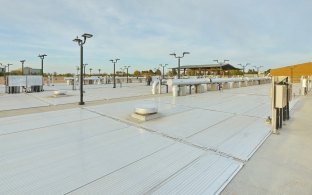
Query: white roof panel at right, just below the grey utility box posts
188,116,271,160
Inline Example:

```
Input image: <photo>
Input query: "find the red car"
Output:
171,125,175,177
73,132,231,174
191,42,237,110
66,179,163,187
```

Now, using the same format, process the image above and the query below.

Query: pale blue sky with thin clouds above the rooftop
0,0,312,73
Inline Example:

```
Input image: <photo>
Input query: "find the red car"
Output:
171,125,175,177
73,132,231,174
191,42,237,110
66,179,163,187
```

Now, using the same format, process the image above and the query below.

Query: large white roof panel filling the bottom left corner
0,123,174,194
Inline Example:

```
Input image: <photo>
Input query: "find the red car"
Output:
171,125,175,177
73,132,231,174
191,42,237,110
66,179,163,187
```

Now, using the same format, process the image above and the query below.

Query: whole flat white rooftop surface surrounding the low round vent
0,85,302,194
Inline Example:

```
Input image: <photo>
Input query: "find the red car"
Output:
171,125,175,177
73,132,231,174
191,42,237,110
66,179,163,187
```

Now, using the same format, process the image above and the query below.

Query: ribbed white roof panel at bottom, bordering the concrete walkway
152,155,242,195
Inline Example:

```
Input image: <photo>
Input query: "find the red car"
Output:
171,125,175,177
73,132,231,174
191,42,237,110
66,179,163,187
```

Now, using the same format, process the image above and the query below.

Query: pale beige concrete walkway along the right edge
222,93,312,195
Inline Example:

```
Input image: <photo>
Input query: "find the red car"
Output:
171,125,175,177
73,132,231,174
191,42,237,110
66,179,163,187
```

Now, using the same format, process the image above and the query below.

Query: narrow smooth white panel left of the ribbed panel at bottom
68,143,204,194
